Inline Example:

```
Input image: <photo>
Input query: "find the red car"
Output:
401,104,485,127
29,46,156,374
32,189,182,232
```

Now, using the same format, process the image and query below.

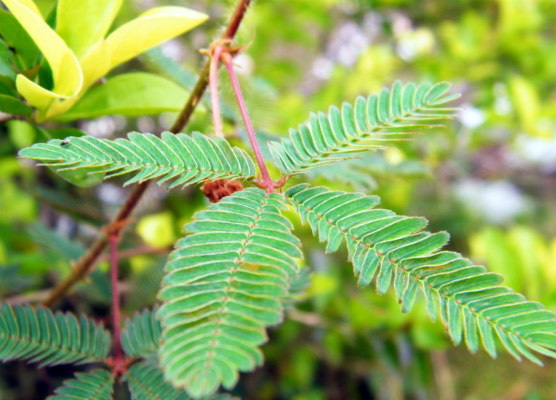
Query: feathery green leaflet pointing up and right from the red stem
269,81,458,174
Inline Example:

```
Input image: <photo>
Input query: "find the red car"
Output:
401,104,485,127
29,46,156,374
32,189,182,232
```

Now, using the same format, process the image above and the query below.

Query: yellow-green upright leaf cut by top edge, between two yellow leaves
56,0,122,57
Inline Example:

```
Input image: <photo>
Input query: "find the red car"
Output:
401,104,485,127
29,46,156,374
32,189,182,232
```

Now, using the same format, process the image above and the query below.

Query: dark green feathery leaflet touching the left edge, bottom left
0,304,110,366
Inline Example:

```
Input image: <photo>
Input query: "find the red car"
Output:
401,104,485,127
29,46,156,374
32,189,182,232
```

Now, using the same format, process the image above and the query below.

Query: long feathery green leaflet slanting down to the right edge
286,184,556,364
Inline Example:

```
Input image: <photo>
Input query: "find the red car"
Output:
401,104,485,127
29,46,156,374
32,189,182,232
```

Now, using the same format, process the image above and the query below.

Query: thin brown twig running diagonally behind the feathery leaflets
42,0,251,306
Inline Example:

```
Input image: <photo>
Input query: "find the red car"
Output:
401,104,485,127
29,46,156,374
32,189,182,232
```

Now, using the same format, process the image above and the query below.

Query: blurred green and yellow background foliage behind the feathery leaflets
0,0,556,400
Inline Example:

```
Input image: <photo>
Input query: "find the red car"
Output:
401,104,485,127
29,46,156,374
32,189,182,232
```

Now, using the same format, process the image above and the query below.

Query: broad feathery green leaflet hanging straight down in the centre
158,188,301,397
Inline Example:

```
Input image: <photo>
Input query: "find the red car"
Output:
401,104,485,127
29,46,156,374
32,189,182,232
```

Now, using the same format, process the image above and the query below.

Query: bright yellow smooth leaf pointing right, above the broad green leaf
81,6,208,86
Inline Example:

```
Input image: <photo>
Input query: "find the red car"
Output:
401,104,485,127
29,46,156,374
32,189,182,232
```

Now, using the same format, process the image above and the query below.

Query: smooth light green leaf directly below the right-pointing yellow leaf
56,72,188,121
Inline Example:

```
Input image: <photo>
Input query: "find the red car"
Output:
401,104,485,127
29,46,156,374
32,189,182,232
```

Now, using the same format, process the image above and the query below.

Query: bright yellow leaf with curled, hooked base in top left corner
3,0,83,110
